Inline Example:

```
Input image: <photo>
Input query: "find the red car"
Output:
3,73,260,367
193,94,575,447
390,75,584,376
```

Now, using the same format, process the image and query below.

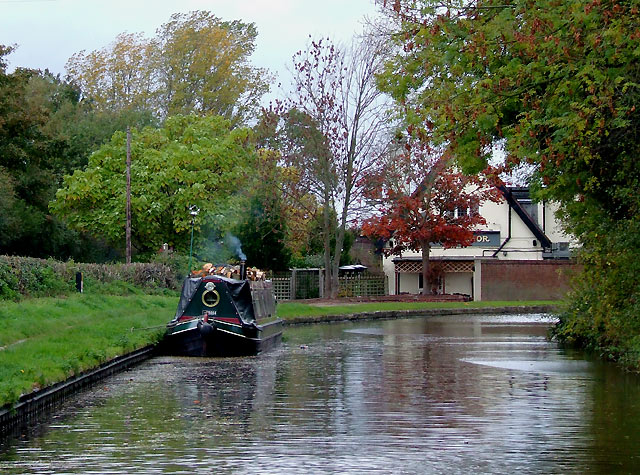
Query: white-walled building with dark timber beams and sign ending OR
383,187,572,300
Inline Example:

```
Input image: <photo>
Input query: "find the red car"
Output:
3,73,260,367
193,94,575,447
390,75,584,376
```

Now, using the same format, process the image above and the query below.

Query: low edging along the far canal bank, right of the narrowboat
283,305,557,326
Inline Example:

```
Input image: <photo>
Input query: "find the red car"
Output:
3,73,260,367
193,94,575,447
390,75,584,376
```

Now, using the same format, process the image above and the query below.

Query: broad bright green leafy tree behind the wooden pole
50,116,254,254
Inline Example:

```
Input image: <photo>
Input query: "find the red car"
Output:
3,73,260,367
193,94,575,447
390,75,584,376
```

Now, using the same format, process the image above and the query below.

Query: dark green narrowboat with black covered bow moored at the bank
161,275,282,356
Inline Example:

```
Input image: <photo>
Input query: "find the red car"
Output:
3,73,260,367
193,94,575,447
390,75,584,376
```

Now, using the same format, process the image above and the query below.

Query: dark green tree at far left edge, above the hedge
0,45,87,258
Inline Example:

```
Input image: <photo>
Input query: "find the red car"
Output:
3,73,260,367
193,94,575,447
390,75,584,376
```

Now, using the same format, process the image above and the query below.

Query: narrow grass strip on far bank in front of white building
276,300,560,320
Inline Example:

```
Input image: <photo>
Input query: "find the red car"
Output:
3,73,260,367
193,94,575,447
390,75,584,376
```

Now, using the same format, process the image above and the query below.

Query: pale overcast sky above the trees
0,0,376,99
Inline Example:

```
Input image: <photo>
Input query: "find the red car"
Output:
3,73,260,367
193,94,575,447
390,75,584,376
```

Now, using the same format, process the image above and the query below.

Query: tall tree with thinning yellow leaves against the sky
67,11,269,124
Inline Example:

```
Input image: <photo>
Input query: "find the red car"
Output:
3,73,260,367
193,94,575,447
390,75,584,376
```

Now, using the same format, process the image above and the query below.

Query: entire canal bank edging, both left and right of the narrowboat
0,305,556,436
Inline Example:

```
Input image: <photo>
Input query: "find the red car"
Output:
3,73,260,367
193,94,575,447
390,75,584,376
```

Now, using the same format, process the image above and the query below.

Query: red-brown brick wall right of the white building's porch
481,260,580,300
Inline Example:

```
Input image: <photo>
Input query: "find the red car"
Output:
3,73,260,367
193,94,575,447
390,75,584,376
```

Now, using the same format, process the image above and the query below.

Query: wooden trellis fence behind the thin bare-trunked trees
271,269,387,301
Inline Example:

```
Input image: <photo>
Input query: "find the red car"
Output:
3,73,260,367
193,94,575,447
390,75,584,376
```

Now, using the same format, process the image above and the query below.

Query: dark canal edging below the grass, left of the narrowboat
0,345,156,436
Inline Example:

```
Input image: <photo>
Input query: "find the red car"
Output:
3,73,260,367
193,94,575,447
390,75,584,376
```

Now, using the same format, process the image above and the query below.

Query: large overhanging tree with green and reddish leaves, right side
381,0,640,360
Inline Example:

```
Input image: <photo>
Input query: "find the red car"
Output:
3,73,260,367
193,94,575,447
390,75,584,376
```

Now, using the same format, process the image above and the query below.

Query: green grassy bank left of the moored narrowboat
0,294,177,406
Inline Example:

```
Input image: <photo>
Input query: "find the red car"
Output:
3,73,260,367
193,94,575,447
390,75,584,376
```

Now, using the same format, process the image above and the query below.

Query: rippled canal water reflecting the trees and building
0,315,640,474
